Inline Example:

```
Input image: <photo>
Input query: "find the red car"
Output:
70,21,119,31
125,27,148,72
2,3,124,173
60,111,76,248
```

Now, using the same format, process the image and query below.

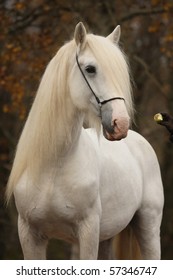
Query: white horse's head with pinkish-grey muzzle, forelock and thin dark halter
71,23,131,141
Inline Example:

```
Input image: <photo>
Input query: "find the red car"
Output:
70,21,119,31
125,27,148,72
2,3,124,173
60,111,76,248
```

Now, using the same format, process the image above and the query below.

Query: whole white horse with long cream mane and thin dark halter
7,23,163,259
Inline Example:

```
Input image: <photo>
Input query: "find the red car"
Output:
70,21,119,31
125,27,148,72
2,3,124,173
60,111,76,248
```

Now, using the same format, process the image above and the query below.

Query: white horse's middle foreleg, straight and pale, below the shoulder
78,215,100,260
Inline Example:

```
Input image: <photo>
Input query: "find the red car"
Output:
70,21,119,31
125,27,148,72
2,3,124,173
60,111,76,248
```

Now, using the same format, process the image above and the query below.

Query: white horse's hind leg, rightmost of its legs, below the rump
133,210,162,260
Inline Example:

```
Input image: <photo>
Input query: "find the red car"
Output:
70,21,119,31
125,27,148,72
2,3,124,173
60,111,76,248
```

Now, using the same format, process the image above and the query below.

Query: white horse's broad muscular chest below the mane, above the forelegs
15,164,98,241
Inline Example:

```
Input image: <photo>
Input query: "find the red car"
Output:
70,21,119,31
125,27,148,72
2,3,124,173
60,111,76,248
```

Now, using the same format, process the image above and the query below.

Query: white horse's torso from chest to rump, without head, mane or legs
15,130,163,258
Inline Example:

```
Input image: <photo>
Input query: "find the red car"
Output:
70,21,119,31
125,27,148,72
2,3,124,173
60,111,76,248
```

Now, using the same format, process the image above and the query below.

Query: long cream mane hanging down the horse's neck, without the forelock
7,41,75,201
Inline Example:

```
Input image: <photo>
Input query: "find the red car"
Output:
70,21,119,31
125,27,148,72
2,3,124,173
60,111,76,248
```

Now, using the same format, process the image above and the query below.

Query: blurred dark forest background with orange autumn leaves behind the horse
0,0,173,259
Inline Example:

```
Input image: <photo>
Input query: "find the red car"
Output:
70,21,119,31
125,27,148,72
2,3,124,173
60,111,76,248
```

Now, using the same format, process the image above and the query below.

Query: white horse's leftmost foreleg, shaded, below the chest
18,216,48,260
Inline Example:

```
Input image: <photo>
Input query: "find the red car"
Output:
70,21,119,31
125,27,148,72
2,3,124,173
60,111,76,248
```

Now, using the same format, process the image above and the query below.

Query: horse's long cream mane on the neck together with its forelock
6,34,133,201
